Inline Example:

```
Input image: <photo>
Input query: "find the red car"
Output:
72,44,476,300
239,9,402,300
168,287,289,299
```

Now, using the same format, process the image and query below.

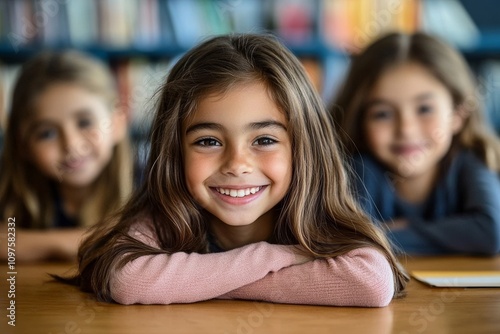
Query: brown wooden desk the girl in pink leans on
0,257,500,334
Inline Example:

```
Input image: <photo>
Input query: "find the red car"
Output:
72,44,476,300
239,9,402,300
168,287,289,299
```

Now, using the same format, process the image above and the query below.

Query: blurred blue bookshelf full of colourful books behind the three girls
0,0,500,148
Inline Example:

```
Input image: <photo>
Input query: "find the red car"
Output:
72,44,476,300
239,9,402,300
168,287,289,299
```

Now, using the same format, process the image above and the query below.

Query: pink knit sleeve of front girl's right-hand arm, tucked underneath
222,248,394,307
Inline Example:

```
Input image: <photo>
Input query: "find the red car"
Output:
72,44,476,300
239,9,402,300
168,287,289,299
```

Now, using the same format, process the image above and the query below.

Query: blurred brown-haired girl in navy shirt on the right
332,33,500,254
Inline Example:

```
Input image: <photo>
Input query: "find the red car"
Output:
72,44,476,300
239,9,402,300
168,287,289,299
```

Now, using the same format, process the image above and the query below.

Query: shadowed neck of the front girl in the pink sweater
210,212,275,250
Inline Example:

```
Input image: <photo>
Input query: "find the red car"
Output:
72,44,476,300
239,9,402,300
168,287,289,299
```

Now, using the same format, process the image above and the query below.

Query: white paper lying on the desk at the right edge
411,270,500,288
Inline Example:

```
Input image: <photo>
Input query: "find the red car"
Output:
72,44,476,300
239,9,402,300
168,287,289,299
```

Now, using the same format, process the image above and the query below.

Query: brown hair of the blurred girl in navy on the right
331,32,500,172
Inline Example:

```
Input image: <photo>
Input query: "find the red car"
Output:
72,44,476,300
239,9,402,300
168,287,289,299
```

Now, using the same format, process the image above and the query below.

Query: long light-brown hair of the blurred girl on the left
0,51,132,229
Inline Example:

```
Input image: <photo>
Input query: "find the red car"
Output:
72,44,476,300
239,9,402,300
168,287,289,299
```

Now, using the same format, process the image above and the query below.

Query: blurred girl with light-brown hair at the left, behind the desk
0,51,132,261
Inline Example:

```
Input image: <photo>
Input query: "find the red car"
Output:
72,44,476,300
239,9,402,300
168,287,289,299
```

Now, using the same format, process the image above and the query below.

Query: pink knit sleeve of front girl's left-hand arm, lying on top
110,223,307,304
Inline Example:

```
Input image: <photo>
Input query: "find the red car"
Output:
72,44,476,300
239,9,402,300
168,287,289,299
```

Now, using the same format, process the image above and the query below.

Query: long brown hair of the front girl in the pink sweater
74,34,407,301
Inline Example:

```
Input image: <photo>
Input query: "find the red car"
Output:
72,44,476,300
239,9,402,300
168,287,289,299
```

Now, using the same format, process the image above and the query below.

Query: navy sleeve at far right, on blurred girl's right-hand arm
401,154,500,255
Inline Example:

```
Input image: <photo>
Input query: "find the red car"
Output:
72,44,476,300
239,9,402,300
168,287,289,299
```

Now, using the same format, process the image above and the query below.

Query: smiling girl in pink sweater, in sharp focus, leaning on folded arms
66,35,407,306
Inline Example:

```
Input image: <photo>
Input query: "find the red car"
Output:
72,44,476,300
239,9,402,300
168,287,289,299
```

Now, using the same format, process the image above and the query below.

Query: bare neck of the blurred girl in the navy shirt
394,168,439,204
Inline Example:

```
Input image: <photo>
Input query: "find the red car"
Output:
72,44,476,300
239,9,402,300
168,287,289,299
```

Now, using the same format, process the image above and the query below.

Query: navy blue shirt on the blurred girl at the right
353,151,500,254
